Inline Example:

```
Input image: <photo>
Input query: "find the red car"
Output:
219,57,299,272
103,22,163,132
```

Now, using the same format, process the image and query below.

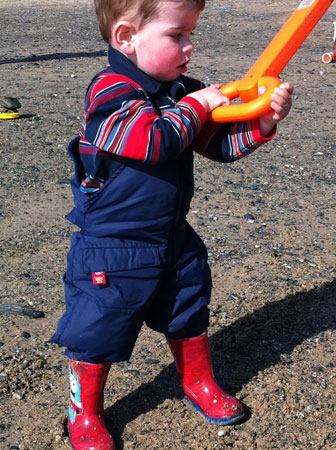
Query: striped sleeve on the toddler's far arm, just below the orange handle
195,119,275,162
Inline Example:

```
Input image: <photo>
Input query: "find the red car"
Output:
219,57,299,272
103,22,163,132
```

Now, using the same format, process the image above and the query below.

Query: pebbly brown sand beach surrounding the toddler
0,0,336,450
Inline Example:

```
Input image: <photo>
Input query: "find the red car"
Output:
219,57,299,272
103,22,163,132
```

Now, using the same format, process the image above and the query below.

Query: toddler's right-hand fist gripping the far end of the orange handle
259,83,294,136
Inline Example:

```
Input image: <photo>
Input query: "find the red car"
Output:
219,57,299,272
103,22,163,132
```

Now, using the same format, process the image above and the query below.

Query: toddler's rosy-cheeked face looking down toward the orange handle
130,0,200,81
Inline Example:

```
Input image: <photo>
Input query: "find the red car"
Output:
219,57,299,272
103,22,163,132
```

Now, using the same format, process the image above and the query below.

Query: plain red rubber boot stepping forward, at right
167,333,244,425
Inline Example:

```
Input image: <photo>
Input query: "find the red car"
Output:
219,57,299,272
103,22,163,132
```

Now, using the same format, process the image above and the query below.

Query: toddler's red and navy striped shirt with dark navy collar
79,48,273,194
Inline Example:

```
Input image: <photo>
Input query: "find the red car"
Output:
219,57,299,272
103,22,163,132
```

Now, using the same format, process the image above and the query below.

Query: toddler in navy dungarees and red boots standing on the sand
52,0,293,450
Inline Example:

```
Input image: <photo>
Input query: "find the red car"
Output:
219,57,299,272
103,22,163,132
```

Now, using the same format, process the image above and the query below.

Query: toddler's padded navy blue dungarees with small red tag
51,47,211,363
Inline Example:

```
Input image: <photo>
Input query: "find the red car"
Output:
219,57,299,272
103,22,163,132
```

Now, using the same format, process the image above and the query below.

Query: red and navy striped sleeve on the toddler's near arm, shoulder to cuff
81,76,207,164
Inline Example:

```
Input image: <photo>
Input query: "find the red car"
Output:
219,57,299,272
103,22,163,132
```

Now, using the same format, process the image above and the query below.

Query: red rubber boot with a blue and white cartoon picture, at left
68,360,114,450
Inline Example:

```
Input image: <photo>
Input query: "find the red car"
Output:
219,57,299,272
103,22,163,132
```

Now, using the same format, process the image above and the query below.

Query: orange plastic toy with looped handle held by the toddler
209,0,333,122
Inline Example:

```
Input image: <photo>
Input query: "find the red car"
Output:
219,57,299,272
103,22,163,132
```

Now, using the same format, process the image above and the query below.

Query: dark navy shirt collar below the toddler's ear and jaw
108,46,163,94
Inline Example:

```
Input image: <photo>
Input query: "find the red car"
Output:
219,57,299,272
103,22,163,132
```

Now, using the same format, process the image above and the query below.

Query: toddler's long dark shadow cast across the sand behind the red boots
106,280,336,450
